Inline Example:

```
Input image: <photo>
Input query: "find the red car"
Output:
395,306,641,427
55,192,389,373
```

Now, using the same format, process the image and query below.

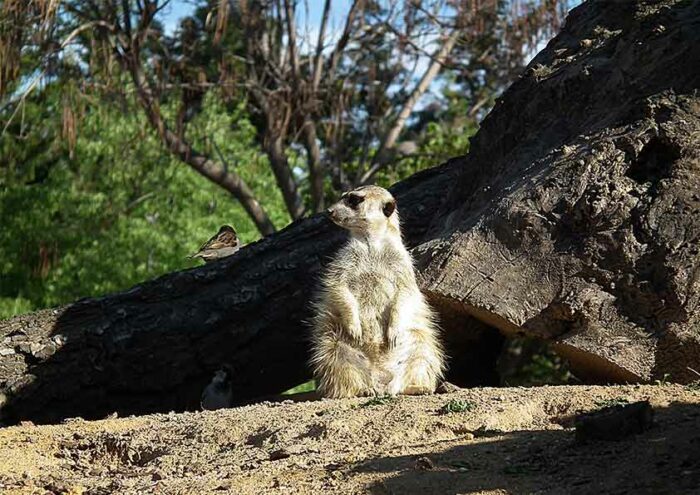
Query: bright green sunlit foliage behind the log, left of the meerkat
0,89,288,318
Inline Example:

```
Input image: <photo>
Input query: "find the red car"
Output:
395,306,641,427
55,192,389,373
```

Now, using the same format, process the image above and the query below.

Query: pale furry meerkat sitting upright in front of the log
311,186,445,398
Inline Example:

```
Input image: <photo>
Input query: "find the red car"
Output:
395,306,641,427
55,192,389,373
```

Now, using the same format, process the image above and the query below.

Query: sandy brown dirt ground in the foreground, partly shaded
0,385,700,494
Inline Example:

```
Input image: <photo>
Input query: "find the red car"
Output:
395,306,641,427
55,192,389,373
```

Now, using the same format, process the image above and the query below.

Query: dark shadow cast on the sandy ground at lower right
355,403,700,495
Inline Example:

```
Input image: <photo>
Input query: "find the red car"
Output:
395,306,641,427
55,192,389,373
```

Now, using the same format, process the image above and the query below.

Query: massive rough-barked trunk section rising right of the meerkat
418,1,700,381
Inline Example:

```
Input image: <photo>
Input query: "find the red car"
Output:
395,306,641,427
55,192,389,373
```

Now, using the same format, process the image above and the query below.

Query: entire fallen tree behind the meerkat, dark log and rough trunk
0,1,700,422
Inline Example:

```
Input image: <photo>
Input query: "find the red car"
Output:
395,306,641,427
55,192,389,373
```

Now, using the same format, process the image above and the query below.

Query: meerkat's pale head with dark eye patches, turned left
327,186,399,236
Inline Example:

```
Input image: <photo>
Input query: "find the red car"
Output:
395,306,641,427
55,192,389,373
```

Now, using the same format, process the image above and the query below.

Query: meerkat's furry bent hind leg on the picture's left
311,335,373,398
